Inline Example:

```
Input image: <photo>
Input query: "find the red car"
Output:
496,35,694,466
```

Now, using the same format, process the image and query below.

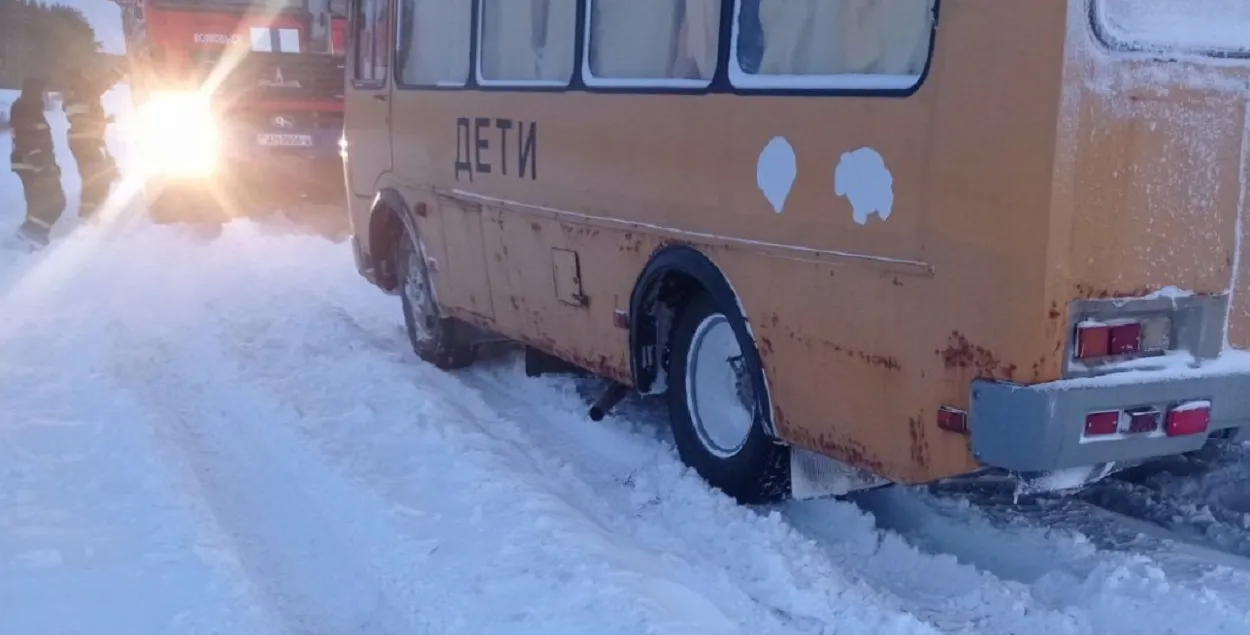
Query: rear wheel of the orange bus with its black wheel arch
630,245,790,503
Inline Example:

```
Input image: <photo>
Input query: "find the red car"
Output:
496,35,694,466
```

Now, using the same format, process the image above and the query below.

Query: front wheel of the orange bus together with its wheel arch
369,190,475,370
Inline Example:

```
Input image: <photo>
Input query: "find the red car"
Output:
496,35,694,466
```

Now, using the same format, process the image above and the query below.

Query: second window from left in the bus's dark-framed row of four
479,0,578,86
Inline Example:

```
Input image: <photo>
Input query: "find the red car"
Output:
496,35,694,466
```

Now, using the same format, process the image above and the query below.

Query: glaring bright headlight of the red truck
135,91,220,178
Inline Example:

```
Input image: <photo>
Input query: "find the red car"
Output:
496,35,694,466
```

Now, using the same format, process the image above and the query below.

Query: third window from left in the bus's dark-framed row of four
586,0,720,86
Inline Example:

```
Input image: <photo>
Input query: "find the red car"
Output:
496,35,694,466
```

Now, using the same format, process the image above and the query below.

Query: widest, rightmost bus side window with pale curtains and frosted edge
730,0,934,90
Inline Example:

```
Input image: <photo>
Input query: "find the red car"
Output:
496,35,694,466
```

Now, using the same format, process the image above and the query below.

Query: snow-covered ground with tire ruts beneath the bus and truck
0,101,1250,635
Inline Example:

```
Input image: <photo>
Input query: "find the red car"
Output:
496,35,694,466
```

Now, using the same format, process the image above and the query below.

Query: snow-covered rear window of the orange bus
1093,0,1250,58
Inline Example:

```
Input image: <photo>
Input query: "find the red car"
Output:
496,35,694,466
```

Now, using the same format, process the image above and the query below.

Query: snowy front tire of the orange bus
395,226,474,370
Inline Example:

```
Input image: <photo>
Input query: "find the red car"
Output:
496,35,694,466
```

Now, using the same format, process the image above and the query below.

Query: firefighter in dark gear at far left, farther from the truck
9,78,65,245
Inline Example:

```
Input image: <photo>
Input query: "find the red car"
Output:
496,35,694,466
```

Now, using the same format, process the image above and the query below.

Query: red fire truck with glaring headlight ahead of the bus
114,0,348,221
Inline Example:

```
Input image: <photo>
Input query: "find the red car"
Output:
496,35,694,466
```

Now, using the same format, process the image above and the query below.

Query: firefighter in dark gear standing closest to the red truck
61,65,119,219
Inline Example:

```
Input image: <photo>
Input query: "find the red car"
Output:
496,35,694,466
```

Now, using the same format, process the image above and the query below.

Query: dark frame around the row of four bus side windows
380,0,945,99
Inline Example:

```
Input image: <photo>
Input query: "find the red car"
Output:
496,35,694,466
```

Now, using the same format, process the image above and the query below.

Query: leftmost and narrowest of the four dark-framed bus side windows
396,0,473,86
